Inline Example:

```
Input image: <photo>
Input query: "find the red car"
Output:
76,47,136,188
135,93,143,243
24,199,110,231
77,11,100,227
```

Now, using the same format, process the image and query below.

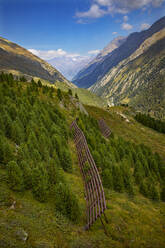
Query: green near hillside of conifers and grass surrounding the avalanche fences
0,74,165,248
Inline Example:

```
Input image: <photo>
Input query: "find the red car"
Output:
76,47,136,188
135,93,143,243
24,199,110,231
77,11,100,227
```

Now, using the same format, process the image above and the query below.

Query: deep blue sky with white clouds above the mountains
0,0,165,60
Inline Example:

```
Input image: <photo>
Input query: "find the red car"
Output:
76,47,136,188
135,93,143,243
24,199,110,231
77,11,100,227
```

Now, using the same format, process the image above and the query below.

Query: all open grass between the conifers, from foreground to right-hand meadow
0,82,165,248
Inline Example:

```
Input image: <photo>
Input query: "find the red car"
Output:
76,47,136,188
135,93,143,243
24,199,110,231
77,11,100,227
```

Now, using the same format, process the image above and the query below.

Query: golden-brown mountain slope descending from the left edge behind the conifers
0,37,73,86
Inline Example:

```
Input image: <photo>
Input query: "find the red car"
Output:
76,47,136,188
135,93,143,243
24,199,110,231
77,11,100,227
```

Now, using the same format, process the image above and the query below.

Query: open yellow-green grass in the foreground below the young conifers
0,171,165,248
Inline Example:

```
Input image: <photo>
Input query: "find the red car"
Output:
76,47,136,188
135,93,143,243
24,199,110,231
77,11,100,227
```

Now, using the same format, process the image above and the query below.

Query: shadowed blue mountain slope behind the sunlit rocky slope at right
73,17,165,88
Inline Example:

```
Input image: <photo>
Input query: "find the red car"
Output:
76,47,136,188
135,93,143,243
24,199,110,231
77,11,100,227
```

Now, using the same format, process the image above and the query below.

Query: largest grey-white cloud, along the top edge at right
76,0,164,22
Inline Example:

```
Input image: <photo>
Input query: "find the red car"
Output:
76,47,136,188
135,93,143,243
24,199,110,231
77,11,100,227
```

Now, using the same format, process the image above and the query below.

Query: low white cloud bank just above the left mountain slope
28,48,80,60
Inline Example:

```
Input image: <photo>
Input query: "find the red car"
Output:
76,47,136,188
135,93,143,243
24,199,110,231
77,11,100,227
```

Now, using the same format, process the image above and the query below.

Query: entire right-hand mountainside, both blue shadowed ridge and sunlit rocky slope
73,17,165,118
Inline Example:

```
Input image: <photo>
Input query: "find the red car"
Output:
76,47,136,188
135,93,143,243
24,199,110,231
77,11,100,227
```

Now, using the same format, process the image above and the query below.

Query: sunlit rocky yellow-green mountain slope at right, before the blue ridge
90,29,165,118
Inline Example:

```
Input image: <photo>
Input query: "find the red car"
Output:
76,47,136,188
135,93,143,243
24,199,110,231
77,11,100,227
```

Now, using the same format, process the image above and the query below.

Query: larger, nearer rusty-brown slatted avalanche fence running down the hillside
71,121,107,229
